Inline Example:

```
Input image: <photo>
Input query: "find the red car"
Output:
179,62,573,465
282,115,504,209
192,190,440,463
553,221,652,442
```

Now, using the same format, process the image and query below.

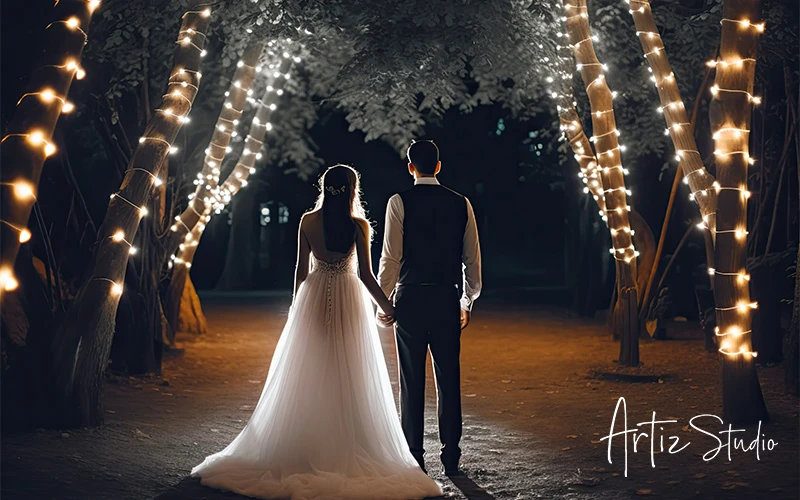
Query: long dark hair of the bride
316,165,367,253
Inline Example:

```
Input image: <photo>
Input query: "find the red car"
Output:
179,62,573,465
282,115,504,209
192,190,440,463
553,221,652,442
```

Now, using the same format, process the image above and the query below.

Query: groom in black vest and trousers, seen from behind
378,141,481,476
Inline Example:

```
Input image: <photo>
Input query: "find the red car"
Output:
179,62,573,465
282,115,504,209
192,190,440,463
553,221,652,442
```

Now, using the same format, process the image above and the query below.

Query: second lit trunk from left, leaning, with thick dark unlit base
53,0,211,426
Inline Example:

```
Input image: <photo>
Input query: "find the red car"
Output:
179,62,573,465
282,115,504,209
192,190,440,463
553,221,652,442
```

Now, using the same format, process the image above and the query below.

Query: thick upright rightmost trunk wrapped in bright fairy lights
709,0,768,423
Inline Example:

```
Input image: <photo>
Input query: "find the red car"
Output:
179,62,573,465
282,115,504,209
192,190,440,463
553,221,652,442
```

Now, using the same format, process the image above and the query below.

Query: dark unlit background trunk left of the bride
217,180,258,290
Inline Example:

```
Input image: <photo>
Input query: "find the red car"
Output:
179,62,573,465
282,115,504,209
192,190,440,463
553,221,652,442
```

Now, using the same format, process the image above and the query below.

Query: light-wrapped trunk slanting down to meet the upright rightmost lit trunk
628,0,717,234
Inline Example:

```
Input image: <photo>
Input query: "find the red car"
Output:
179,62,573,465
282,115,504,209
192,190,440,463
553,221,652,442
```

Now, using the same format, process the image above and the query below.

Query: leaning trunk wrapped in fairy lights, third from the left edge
165,43,264,255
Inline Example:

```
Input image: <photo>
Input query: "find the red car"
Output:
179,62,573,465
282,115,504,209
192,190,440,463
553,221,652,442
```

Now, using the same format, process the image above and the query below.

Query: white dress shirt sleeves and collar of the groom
378,177,482,311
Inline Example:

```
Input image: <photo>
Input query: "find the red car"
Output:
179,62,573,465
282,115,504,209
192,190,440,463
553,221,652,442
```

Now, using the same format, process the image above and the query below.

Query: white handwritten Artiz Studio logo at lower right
600,397,778,477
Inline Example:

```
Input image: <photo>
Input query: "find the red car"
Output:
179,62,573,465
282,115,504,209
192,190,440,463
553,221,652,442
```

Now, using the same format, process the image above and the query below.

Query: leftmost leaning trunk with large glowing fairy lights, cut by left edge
0,0,100,294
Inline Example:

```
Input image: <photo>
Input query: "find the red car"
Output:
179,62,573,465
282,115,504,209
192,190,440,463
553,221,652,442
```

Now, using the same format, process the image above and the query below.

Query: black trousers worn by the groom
395,284,461,468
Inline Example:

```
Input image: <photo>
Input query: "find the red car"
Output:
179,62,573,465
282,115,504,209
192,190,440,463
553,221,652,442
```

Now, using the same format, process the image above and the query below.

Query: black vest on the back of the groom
398,184,467,286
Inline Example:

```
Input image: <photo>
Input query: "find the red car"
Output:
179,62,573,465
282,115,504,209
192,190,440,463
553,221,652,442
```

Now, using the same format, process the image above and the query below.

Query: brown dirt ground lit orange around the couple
2,296,800,500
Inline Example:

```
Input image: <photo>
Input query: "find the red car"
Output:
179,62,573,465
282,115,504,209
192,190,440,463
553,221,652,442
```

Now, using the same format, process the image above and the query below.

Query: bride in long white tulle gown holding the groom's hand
192,165,442,500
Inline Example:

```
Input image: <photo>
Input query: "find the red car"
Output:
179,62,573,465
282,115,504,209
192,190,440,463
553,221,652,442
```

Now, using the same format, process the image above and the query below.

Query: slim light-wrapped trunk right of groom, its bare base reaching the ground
564,0,639,366
